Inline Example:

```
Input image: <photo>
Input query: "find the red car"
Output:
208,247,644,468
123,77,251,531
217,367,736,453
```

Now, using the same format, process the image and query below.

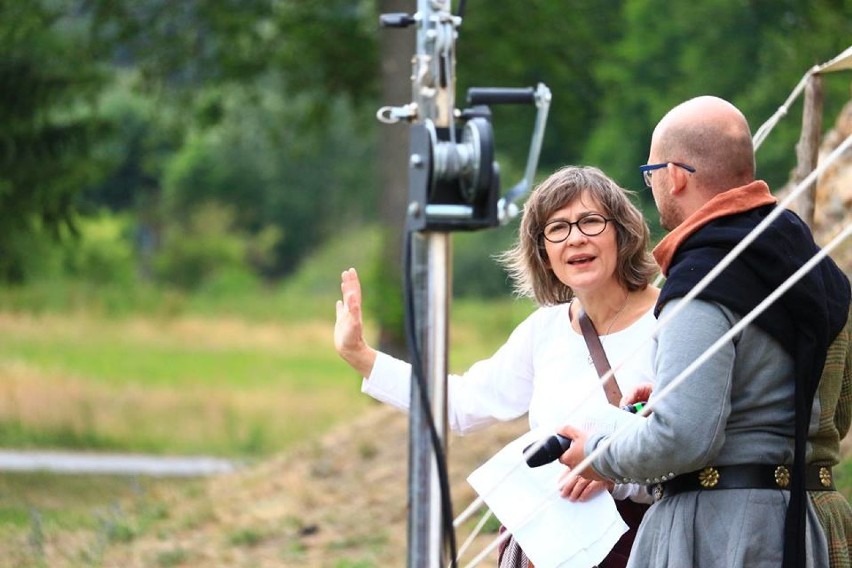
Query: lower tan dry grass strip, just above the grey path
0,363,370,454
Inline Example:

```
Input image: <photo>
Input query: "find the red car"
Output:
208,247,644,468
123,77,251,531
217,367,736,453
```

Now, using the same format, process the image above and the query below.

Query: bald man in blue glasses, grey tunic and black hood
561,96,850,568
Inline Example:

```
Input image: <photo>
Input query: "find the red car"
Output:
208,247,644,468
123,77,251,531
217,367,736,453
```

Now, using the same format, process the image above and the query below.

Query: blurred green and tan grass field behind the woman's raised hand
0,290,528,457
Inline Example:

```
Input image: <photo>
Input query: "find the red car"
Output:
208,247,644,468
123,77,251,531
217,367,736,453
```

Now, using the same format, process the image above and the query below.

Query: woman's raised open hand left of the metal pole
334,268,376,377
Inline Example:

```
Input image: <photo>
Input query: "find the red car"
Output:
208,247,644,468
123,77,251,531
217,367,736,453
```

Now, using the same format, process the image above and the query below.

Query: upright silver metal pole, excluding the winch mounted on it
408,0,455,568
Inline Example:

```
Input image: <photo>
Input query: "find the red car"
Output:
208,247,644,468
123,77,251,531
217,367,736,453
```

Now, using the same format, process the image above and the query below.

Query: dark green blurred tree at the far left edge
0,2,103,282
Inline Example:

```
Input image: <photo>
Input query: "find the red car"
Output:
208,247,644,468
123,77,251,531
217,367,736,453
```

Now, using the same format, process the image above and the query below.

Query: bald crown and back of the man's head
651,96,755,194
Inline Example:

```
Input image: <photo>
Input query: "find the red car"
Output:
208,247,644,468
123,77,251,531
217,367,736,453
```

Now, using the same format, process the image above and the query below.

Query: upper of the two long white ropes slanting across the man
460,136,852,566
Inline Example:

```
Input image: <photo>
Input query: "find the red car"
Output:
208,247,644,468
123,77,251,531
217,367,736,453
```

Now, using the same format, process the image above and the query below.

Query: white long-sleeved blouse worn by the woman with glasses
361,304,656,434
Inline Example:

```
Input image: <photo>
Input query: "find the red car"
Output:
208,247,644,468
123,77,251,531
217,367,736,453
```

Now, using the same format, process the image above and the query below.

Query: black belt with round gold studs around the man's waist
648,464,834,501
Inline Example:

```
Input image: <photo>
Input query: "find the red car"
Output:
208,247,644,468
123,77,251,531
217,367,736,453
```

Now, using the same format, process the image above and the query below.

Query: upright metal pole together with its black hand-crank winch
376,0,551,568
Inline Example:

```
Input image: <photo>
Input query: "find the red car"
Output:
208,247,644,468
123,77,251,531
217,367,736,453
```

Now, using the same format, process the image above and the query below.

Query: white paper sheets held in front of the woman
468,405,641,568
